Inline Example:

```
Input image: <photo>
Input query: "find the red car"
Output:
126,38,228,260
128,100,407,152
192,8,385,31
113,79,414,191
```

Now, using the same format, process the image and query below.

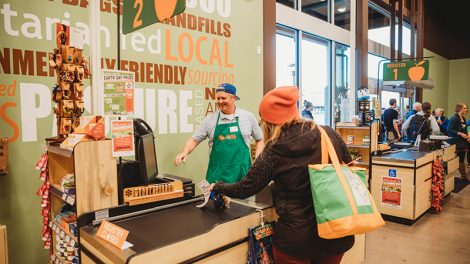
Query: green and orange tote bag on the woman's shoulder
308,127,385,239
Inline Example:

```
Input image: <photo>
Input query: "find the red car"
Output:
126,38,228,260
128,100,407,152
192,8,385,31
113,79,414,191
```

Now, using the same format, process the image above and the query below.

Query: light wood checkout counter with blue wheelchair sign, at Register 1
370,145,458,224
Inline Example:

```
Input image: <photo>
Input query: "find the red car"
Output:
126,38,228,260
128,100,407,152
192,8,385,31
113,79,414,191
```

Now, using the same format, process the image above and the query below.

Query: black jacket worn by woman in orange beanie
214,124,354,258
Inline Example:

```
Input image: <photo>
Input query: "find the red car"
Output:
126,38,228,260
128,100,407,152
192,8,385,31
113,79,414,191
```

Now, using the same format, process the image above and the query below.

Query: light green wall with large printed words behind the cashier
0,0,263,263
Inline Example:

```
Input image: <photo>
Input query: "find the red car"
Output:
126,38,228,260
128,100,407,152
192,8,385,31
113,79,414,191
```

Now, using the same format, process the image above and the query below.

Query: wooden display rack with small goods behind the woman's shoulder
335,120,378,183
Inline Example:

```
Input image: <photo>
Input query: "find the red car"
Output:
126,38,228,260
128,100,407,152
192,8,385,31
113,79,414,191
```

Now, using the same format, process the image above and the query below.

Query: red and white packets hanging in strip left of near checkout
35,153,52,254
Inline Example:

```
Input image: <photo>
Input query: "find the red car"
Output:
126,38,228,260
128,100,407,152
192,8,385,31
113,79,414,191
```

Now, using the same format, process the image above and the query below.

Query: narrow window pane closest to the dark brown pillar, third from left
334,44,348,123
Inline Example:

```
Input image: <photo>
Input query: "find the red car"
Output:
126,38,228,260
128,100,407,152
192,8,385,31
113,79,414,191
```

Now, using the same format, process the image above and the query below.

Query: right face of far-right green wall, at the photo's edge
448,59,470,113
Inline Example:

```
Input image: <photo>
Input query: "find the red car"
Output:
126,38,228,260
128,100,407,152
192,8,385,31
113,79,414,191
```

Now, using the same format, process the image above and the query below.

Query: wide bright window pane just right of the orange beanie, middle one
300,34,331,125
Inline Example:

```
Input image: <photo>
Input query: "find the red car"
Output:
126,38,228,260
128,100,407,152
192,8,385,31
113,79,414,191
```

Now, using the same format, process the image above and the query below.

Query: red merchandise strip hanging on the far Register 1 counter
431,156,445,214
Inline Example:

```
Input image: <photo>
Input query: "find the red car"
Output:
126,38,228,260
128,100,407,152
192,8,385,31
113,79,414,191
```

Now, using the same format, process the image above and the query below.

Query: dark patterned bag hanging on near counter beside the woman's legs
248,210,274,264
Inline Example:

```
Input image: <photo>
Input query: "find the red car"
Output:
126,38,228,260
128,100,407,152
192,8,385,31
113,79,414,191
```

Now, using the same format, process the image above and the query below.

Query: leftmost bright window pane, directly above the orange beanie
276,26,297,87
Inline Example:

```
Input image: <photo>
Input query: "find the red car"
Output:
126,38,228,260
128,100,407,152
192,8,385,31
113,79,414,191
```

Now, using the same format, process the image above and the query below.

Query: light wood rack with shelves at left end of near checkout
47,140,118,263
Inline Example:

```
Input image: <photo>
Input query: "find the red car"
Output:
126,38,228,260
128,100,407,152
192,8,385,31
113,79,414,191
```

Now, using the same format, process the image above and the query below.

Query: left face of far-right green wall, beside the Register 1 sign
423,49,449,112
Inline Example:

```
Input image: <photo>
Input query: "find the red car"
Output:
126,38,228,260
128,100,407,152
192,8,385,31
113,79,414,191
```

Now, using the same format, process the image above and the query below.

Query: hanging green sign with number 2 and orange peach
122,0,186,34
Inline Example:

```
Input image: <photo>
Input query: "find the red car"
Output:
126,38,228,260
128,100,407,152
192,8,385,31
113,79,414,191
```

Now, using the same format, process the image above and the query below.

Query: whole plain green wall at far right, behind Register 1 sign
423,49,470,116
